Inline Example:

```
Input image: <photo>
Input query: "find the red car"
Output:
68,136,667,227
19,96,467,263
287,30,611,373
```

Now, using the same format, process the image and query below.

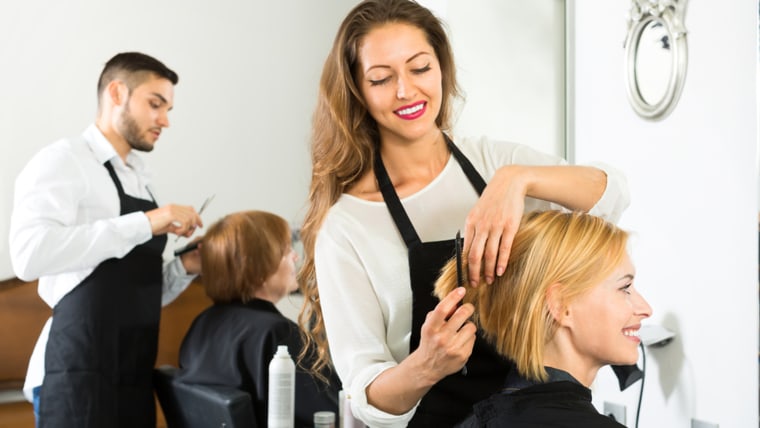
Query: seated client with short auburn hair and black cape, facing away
179,211,339,428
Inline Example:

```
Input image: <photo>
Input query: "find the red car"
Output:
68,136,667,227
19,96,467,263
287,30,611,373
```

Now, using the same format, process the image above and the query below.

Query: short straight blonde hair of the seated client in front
435,211,628,381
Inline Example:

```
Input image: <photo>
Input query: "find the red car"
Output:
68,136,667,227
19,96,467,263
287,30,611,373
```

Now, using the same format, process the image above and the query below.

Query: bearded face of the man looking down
116,75,174,152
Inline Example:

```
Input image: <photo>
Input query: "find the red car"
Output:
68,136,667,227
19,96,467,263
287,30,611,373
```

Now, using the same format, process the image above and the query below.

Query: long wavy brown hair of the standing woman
298,0,459,371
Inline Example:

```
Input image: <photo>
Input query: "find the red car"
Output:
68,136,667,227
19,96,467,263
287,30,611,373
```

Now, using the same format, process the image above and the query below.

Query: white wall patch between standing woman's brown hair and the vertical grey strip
446,0,565,156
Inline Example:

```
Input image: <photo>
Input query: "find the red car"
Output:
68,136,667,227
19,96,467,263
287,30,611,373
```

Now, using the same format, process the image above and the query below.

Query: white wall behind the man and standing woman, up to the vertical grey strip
0,0,564,279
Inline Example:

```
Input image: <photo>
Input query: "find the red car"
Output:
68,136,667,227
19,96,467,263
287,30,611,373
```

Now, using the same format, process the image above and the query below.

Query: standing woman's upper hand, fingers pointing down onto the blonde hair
463,165,529,287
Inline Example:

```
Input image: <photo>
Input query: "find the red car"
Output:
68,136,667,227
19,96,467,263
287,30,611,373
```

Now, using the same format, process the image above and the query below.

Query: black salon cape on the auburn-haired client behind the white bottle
179,299,340,428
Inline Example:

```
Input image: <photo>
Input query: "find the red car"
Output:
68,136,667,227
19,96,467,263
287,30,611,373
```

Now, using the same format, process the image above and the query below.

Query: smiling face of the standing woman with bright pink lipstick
357,23,442,143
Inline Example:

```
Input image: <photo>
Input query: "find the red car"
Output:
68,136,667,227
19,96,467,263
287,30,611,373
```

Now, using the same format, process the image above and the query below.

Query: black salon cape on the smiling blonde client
457,381,624,428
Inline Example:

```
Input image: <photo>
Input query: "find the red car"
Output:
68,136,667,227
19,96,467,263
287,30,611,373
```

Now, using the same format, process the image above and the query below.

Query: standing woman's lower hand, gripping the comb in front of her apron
414,287,476,384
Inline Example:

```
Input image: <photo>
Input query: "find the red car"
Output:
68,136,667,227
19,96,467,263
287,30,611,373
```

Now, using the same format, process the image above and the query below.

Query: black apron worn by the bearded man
39,162,166,428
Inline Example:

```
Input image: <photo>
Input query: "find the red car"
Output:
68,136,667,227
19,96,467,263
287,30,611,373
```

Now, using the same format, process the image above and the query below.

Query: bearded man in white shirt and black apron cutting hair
10,52,202,428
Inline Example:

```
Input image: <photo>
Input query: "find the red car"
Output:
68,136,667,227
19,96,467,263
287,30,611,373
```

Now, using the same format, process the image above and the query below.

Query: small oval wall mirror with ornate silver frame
624,0,687,120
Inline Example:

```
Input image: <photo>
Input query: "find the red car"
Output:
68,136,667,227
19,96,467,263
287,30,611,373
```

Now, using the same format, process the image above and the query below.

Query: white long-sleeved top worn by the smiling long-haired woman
315,138,629,427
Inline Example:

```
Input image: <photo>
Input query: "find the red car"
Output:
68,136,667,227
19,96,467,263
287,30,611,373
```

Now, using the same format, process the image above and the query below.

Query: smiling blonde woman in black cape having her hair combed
435,211,652,428
